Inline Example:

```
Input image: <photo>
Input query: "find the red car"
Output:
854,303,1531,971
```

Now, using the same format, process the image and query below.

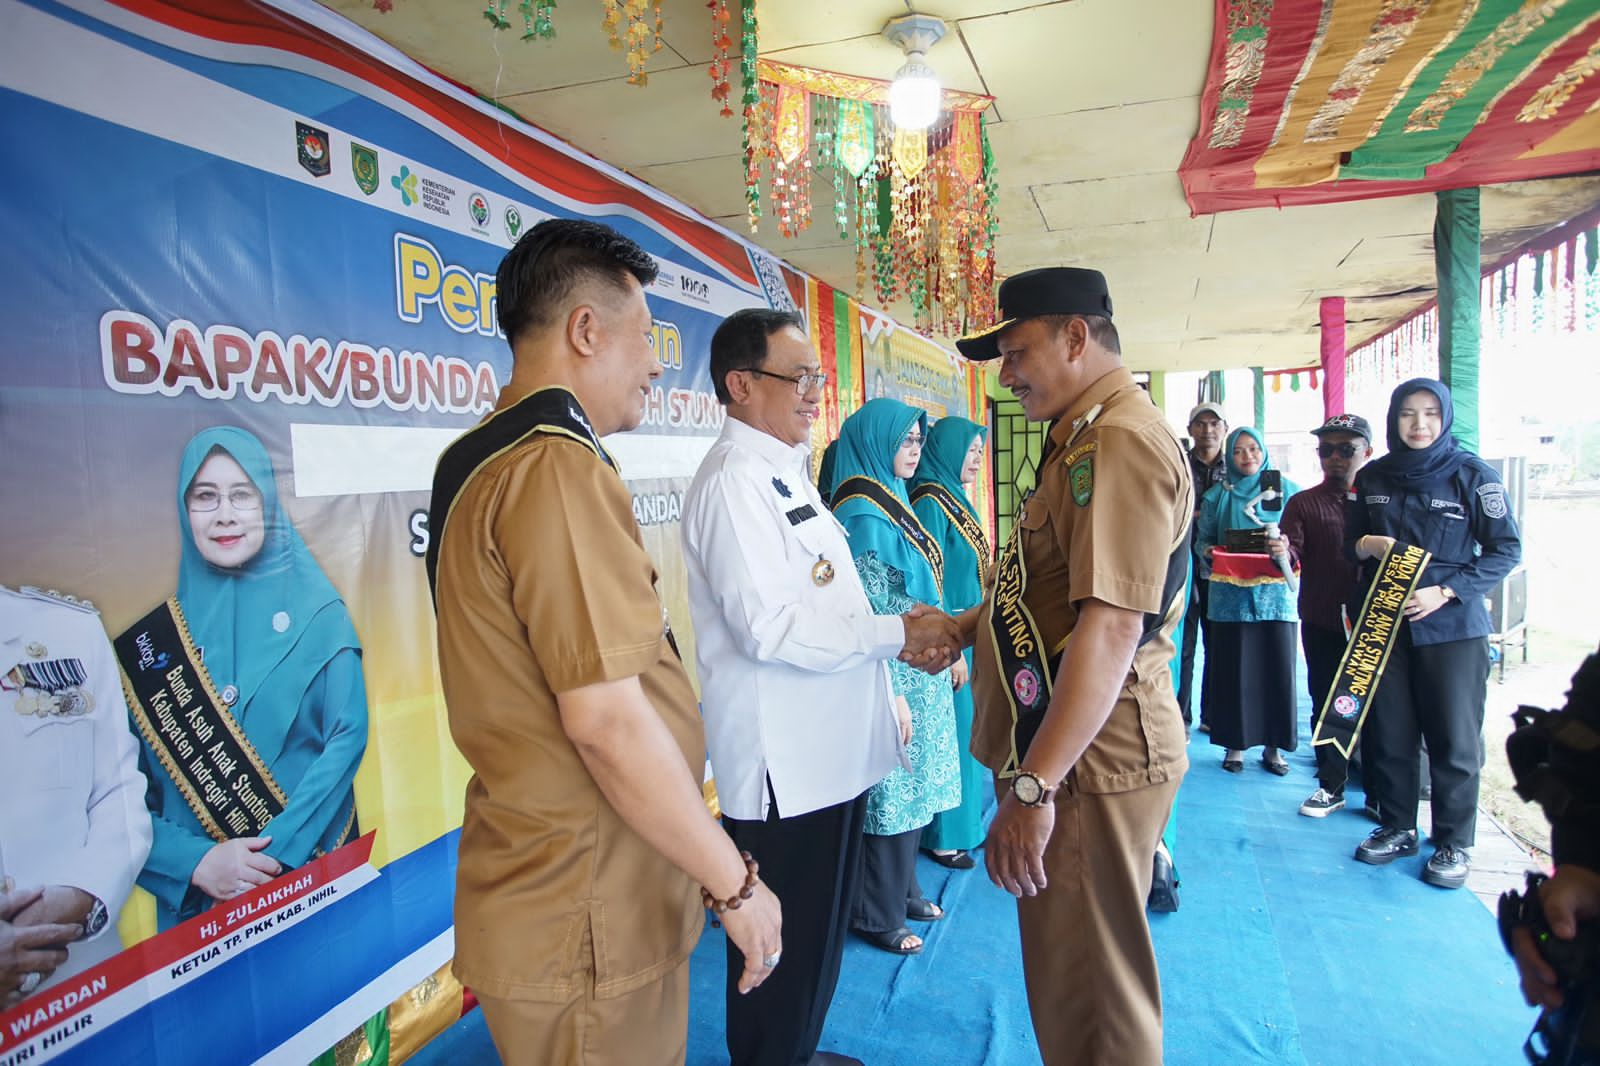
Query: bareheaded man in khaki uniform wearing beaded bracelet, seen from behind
427,219,781,1066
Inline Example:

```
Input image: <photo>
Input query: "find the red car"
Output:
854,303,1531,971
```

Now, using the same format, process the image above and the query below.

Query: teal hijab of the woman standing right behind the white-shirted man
834,397,939,605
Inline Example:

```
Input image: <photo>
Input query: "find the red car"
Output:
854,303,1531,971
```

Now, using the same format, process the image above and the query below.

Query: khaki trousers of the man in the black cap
1016,779,1178,1066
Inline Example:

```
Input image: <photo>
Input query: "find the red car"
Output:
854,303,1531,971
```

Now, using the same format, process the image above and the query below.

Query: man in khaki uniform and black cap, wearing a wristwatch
958,267,1194,1066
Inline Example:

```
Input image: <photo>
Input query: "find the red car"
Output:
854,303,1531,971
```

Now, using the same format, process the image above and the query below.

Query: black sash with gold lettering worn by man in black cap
989,505,1054,778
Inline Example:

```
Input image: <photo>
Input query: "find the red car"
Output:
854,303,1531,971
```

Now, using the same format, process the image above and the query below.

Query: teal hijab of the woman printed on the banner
178,426,362,765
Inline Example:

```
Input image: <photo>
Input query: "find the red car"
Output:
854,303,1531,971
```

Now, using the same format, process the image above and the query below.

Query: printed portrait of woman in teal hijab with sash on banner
115,426,366,930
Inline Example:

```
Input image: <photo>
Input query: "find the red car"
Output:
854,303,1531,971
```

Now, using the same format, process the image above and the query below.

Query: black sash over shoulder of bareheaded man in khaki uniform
424,386,618,605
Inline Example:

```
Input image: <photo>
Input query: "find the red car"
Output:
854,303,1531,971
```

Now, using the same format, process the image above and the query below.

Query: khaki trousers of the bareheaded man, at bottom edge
478,959,690,1066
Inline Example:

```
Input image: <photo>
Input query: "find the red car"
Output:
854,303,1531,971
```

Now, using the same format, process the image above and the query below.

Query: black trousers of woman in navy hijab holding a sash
1362,624,1490,848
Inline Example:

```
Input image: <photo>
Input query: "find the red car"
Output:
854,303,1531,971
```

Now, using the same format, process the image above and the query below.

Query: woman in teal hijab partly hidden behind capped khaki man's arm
910,415,994,869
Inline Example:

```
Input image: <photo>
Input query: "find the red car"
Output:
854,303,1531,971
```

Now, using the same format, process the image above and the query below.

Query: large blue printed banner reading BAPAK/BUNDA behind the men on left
0,0,825,1066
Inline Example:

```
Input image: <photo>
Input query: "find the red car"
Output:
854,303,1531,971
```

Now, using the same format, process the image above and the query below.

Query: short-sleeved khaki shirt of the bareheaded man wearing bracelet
435,385,706,1002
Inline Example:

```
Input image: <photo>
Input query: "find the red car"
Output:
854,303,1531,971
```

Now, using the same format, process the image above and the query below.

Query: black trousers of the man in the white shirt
722,786,867,1066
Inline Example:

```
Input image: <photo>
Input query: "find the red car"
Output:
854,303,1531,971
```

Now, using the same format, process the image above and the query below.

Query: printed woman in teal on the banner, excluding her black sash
139,426,366,928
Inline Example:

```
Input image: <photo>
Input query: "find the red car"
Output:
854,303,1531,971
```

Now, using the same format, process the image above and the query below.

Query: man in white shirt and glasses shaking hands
683,309,958,1066
